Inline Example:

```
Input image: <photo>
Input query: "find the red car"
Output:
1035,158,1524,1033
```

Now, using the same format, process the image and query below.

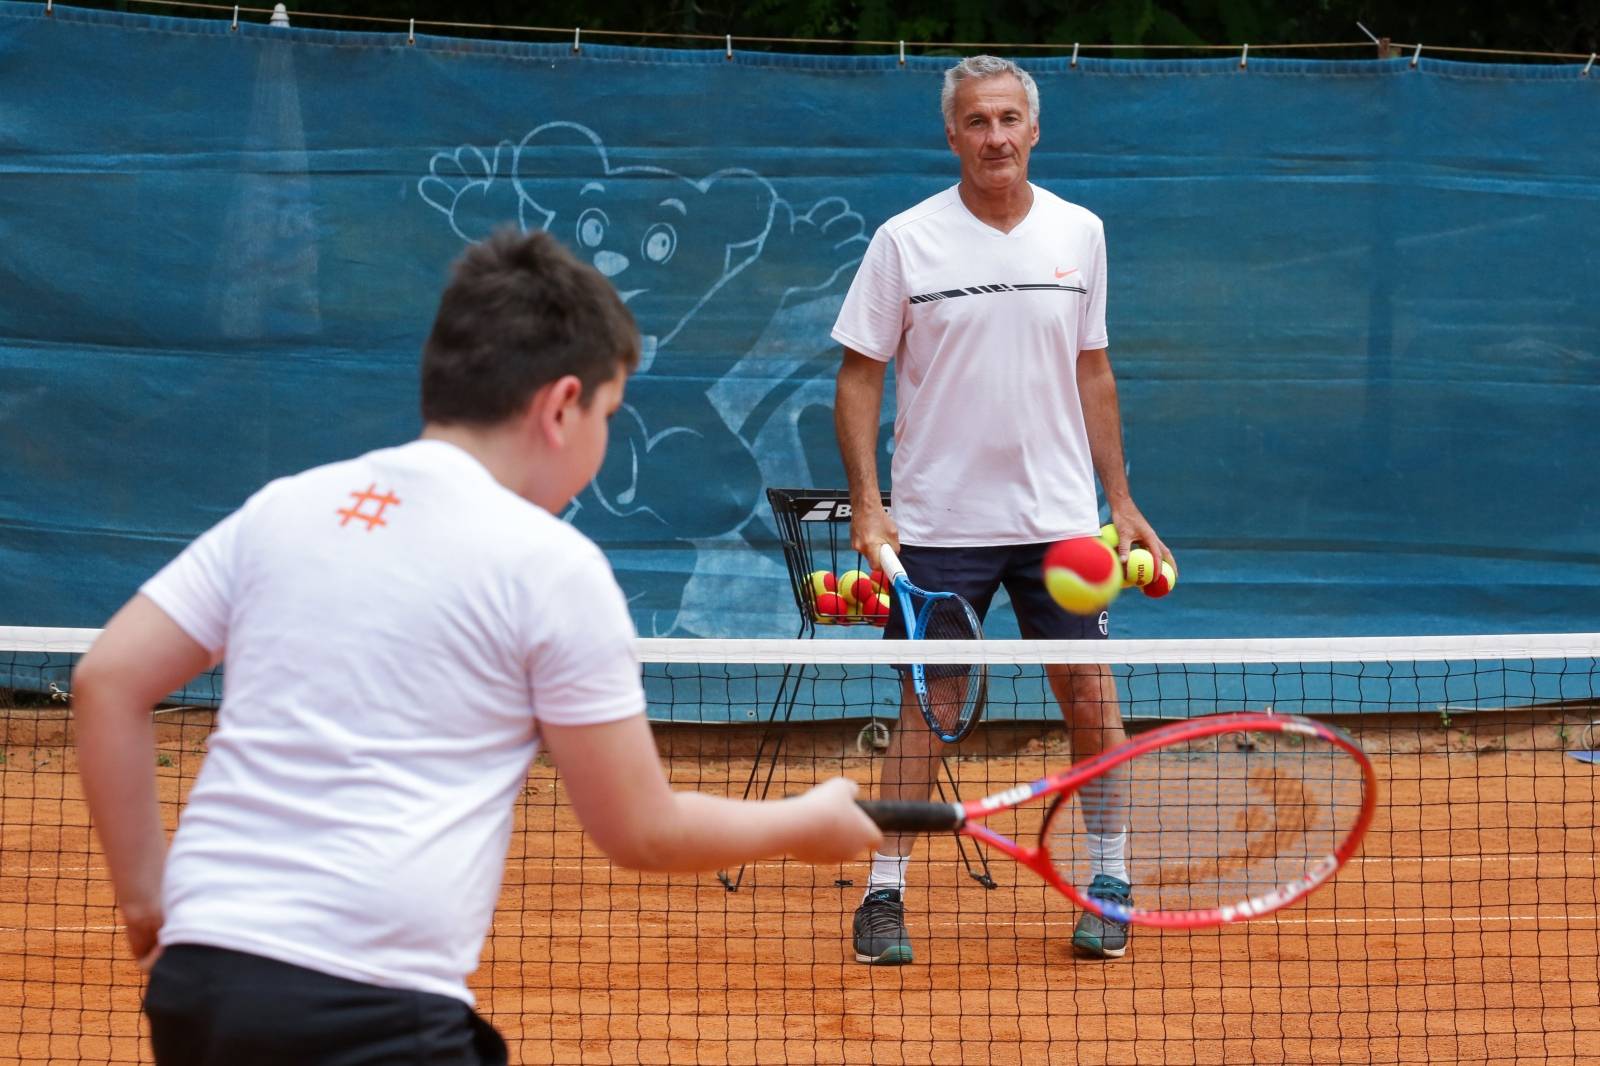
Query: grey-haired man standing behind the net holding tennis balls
834,56,1171,964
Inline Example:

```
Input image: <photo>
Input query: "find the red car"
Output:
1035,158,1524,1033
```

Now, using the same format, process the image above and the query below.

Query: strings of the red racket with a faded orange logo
1043,731,1363,911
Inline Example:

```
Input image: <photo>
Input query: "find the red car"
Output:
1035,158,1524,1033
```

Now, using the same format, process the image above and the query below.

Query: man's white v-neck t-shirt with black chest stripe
834,186,1107,547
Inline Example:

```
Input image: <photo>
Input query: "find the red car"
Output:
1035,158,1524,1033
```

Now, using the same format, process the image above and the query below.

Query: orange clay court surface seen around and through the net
0,707,1600,1064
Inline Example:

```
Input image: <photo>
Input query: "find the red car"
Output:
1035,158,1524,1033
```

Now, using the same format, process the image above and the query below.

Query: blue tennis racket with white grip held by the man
878,544,989,744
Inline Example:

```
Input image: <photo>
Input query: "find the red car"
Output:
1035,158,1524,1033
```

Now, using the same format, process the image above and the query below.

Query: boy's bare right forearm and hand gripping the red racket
539,714,883,874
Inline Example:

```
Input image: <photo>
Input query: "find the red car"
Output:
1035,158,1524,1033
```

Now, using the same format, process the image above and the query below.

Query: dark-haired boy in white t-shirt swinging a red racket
74,234,882,1066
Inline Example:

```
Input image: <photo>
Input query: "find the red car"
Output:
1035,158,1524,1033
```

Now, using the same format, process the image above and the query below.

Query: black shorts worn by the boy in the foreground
144,944,507,1066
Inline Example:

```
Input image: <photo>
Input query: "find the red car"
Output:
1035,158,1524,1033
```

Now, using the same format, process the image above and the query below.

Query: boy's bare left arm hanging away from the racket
72,595,213,967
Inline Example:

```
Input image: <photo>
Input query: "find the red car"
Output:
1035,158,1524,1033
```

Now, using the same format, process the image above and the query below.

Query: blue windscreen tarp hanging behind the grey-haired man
0,2,1600,637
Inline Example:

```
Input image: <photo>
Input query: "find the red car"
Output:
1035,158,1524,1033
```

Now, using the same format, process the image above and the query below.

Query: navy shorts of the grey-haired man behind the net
883,543,1110,640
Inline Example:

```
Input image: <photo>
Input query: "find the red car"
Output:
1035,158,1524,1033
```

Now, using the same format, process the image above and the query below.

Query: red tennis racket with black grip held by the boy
861,714,1378,928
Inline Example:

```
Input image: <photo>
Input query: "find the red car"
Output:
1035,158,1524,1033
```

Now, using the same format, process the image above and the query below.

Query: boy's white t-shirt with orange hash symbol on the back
141,440,645,1004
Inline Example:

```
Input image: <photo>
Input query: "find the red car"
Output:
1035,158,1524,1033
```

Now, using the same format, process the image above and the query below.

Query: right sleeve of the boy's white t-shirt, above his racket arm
526,546,645,725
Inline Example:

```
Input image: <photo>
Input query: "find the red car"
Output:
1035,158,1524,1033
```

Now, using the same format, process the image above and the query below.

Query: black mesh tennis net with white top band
0,631,1600,1064
